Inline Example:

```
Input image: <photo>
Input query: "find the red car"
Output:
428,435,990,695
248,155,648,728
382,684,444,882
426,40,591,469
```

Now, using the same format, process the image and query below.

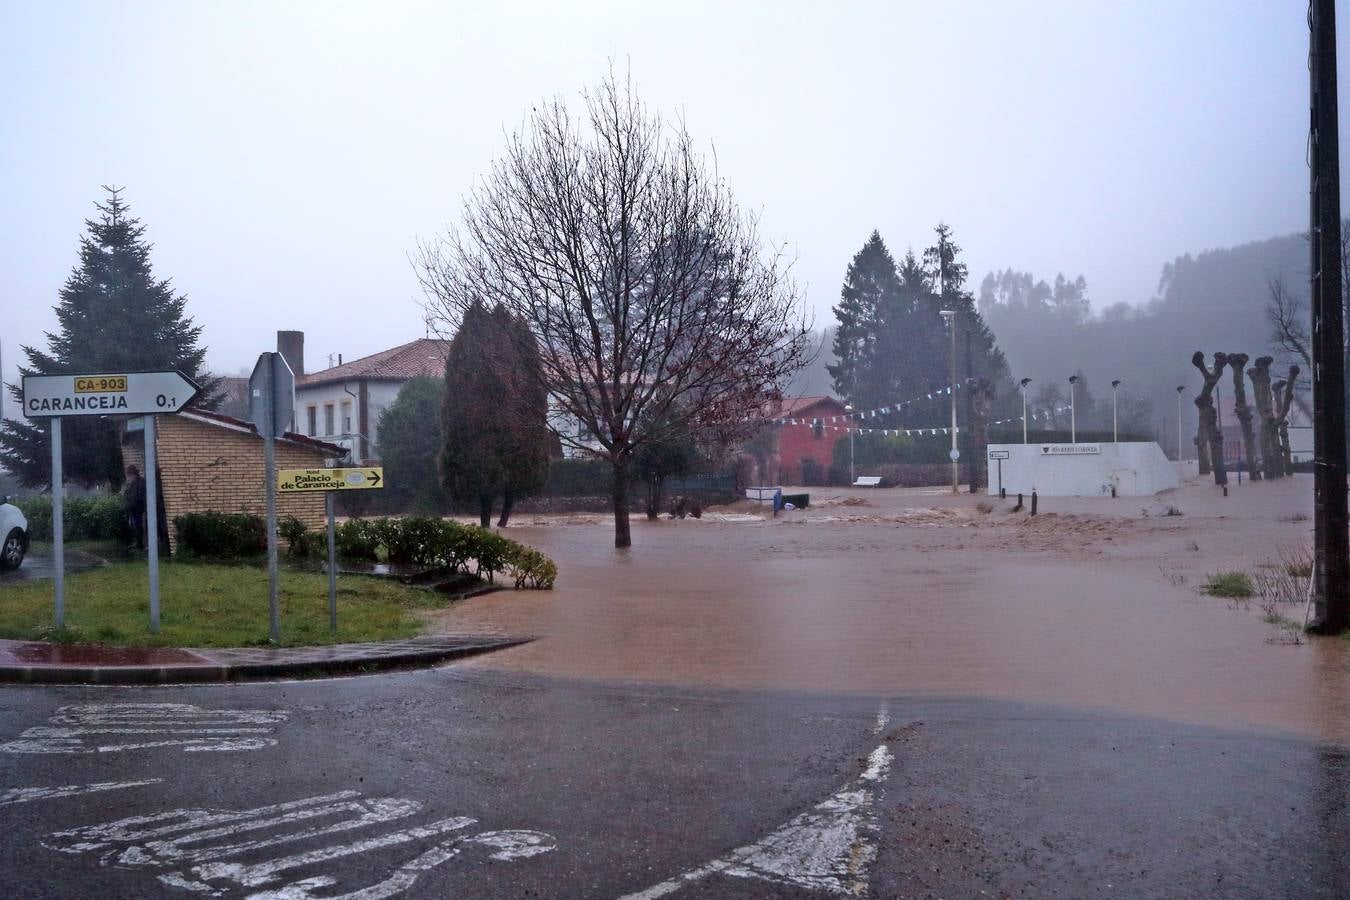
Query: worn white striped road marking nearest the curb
0,703,286,754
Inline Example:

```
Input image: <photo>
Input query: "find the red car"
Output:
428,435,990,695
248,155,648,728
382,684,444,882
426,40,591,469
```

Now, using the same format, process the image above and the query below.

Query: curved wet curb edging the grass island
0,637,535,684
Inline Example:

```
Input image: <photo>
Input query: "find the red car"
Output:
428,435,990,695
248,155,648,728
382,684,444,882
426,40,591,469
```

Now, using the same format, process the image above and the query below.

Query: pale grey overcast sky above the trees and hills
0,0,1328,394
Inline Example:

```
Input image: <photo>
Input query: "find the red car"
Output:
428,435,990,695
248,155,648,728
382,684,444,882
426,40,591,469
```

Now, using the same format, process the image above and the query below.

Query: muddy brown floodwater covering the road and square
437,476,1350,742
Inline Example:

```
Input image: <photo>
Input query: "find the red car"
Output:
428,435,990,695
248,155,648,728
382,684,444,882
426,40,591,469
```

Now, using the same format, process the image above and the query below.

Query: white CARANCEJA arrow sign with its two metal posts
23,371,201,631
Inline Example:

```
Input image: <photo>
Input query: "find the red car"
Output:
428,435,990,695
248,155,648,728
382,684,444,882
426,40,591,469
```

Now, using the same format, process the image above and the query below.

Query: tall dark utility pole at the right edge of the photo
1308,0,1350,634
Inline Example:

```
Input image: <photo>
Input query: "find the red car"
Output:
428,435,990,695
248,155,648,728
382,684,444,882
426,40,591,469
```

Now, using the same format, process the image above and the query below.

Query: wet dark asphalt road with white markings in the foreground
0,667,1350,900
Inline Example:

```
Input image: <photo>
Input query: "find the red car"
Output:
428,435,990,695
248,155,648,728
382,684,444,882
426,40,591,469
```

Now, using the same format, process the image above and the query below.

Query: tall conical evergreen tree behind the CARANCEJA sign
0,188,213,487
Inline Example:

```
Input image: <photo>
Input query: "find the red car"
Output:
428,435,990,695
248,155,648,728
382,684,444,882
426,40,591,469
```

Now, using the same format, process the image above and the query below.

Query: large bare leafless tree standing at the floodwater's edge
417,74,810,546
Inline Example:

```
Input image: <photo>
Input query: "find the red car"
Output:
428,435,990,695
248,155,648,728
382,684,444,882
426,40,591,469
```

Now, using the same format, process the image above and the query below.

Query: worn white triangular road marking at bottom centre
621,743,894,900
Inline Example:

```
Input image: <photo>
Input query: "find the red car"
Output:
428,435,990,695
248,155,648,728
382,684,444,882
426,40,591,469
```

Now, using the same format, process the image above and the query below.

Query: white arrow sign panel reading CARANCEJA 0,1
23,371,201,418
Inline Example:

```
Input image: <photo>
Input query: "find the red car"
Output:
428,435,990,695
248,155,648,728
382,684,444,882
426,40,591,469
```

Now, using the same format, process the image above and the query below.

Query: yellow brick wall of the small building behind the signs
122,416,325,553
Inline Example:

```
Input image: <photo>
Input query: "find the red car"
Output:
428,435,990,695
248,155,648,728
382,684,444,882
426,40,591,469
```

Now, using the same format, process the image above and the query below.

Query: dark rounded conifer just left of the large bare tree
440,304,549,528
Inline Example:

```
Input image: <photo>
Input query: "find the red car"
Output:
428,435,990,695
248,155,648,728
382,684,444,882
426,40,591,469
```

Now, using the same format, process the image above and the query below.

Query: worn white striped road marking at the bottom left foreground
43,791,556,900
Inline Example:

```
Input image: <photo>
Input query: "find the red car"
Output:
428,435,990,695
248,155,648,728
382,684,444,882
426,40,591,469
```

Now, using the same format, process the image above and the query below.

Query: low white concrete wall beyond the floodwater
988,441,1177,497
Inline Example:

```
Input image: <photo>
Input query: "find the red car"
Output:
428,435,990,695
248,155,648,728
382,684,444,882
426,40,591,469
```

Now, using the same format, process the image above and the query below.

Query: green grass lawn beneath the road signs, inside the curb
0,561,446,646
